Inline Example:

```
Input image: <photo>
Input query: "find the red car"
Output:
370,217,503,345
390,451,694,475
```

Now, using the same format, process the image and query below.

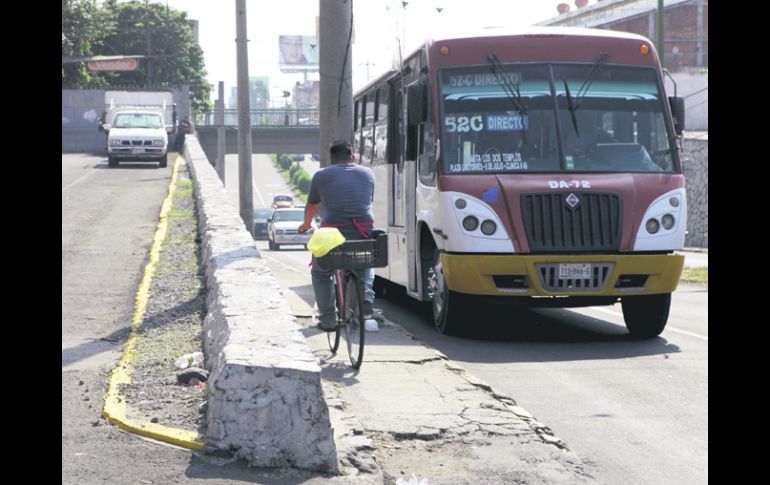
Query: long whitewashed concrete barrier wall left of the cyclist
184,135,338,473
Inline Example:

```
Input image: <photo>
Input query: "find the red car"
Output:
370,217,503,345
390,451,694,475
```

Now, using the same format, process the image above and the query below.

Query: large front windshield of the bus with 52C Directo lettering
439,58,676,174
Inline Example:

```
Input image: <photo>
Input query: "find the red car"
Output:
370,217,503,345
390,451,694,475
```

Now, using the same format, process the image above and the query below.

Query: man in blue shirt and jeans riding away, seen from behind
297,140,374,332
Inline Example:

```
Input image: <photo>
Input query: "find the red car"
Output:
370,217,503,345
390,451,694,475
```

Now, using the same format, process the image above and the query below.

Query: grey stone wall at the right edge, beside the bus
680,131,709,248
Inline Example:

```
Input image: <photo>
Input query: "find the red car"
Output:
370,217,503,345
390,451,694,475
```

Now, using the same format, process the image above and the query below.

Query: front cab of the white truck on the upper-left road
105,110,168,168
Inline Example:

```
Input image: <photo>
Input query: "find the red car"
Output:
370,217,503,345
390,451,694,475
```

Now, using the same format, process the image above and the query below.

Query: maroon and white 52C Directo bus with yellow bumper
354,27,687,338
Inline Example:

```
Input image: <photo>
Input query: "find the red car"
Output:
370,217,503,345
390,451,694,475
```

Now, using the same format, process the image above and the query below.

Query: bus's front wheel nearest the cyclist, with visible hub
423,250,463,335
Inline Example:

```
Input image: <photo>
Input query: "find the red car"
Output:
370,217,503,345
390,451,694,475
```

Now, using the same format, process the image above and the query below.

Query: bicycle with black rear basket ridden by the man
316,230,388,369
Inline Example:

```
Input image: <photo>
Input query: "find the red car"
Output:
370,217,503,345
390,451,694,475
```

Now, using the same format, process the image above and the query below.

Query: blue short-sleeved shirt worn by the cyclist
307,163,374,236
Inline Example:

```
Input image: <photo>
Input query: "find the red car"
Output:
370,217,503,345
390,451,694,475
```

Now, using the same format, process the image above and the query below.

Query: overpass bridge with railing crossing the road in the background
191,108,320,162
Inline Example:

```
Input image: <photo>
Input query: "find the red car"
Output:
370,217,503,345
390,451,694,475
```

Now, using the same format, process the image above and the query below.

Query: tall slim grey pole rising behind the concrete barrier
235,0,254,234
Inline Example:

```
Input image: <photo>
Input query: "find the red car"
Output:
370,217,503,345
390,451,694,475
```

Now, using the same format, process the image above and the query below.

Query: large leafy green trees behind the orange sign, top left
62,0,212,109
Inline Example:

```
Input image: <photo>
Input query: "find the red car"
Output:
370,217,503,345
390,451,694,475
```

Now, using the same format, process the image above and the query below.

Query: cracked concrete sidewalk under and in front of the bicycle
278,291,597,485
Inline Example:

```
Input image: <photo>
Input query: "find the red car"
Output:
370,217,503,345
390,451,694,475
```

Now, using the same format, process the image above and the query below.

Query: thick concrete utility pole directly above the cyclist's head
318,0,353,167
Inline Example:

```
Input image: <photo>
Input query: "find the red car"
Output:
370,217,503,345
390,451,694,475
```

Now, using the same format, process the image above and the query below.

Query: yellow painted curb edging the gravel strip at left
102,156,204,450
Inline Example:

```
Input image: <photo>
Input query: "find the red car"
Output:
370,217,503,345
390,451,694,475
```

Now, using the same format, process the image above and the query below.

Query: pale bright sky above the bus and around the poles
158,0,568,105
